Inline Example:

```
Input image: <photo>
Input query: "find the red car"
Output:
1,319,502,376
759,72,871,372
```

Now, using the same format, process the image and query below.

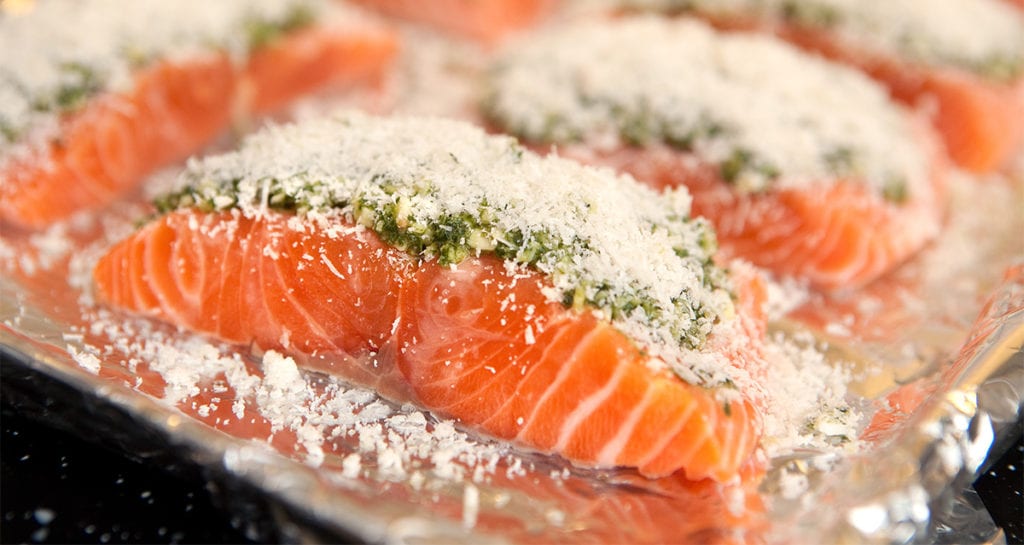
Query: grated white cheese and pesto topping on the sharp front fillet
155,113,734,385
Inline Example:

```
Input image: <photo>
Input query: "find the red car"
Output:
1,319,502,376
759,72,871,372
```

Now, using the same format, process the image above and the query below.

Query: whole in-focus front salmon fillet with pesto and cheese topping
94,114,765,480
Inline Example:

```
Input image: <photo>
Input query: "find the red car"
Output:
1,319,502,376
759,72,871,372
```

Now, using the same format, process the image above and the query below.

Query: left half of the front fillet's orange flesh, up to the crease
87,208,407,385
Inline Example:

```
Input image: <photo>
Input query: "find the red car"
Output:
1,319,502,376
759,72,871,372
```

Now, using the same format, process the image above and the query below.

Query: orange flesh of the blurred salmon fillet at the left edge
0,9,396,228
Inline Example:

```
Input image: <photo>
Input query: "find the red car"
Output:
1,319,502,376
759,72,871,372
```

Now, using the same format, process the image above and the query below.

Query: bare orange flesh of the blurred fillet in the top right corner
627,0,1024,173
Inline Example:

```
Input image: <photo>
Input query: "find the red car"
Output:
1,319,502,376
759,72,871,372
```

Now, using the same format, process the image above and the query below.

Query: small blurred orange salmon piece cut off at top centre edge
357,0,554,43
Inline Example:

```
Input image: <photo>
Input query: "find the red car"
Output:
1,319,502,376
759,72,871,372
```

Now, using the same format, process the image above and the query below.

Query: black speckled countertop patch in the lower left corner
0,404,259,543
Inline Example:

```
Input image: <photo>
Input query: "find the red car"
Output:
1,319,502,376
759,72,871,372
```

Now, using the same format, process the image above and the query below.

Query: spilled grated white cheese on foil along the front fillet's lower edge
68,309,522,483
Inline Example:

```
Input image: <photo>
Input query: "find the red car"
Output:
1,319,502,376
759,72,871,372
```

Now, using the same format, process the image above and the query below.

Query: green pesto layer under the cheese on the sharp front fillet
154,170,728,350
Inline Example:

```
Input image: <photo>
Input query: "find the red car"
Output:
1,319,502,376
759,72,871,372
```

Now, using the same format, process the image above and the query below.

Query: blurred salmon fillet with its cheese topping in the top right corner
623,0,1024,173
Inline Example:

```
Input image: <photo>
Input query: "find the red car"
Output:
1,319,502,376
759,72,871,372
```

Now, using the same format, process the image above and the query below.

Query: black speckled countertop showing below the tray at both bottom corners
0,356,1024,543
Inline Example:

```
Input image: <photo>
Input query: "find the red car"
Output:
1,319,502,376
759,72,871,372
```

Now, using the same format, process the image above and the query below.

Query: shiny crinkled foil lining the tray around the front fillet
0,10,1024,544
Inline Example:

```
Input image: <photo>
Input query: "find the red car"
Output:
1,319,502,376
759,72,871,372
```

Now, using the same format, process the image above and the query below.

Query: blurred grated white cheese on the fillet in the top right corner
614,0,1024,80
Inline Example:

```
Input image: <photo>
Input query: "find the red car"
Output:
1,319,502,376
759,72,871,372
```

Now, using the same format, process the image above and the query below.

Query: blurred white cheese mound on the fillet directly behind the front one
484,16,929,200
